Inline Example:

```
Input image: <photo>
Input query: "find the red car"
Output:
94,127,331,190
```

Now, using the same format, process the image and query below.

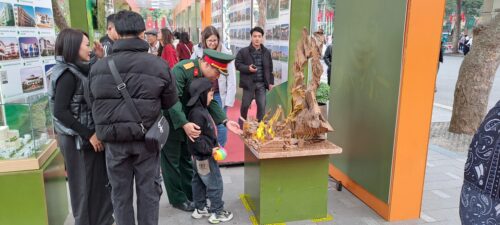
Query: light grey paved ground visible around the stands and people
61,56,476,225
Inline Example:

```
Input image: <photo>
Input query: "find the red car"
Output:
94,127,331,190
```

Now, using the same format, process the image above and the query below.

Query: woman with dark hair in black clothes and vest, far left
49,29,114,225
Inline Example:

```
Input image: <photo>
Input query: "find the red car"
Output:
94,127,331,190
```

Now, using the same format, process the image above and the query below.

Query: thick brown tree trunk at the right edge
449,15,500,134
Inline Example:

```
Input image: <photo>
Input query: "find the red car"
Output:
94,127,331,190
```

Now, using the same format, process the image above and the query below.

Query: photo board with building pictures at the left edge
0,0,56,103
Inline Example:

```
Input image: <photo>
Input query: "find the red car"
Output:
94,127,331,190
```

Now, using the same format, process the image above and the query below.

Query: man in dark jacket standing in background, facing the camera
235,27,274,126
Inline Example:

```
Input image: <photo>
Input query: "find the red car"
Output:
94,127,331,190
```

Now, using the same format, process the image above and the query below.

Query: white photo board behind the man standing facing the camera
217,0,290,85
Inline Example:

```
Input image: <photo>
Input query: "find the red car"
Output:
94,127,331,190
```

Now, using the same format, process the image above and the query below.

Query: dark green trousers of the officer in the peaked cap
161,138,193,205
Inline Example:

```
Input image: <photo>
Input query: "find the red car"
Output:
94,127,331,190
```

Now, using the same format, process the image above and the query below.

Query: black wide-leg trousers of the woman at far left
57,135,114,225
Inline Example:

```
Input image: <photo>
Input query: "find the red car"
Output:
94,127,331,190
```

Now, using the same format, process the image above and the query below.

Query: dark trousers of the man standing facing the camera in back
240,82,266,121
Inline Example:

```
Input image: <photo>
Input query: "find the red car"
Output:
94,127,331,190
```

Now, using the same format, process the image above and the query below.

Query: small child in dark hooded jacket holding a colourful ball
187,78,233,224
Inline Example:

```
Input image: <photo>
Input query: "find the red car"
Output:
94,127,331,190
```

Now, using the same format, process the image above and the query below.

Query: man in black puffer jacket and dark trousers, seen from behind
89,11,179,225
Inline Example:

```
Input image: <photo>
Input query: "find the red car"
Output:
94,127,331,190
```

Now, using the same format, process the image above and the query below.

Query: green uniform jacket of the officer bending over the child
163,59,227,141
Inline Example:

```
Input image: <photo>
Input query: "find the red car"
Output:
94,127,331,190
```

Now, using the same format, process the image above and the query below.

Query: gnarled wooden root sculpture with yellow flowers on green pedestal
243,28,333,151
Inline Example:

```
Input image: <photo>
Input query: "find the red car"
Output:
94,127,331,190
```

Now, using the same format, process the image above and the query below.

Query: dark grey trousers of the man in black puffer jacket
104,142,162,225
